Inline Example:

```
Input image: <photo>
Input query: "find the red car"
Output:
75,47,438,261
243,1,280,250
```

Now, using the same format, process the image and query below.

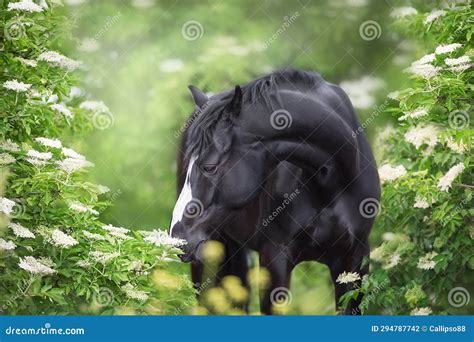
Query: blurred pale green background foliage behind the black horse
65,0,436,314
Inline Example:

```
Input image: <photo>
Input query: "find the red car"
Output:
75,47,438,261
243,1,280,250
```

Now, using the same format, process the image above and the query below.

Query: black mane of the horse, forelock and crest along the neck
184,69,322,165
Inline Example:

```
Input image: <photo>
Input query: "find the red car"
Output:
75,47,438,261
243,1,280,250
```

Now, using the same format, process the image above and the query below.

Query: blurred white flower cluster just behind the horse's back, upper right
340,76,384,109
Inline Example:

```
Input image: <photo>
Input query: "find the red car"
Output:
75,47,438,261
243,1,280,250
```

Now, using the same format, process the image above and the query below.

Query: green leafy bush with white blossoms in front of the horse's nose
0,1,194,314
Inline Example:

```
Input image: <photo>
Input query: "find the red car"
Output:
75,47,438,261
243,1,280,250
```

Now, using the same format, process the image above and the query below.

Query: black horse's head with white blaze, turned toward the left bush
170,86,266,261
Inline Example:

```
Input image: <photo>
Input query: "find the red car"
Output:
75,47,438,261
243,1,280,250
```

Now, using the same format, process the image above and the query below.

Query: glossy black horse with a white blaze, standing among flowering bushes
170,70,380,314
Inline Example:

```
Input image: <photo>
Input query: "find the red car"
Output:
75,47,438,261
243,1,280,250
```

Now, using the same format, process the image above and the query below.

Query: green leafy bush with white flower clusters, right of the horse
347,5,474,314
